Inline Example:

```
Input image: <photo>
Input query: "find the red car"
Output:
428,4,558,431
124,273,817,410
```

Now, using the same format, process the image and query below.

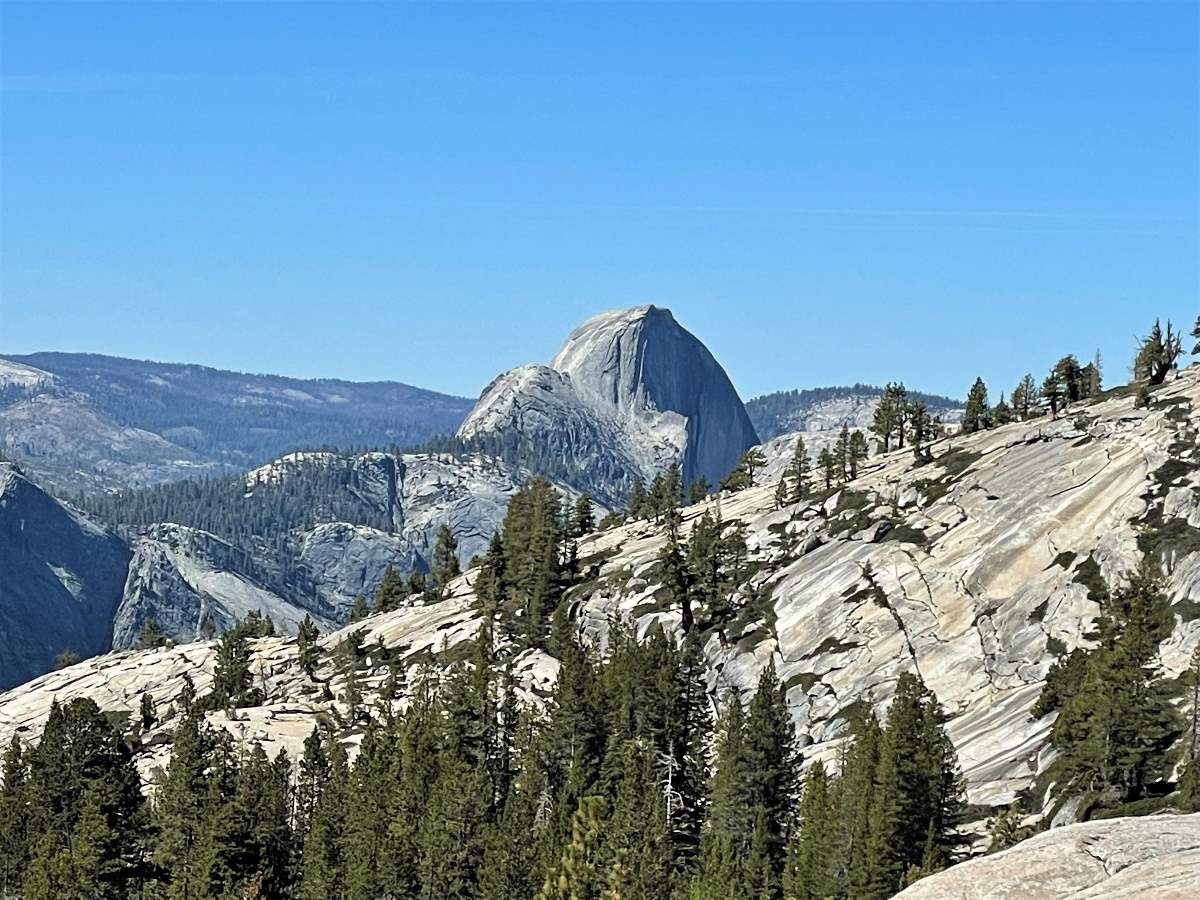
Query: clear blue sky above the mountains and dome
0,0,1200,397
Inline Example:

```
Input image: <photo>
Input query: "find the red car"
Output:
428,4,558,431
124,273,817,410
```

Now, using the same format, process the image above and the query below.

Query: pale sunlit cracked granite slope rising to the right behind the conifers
0,367,1200,804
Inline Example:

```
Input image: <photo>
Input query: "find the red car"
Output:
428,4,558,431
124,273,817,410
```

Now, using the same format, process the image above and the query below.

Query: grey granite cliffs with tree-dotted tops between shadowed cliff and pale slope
104,451,590,649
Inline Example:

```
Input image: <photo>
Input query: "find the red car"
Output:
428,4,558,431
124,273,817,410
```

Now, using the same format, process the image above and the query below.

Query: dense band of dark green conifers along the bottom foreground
0,607,961,900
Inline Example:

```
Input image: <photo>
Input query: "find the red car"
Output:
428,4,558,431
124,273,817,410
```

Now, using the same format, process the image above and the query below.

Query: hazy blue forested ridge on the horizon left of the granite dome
0,353,472,494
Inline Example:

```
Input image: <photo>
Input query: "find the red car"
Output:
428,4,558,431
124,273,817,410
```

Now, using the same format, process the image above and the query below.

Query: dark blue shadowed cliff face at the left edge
0,463,128,689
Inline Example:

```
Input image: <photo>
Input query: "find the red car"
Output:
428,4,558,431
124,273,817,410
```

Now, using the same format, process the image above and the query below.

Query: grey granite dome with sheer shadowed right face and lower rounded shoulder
458,306,758,499
